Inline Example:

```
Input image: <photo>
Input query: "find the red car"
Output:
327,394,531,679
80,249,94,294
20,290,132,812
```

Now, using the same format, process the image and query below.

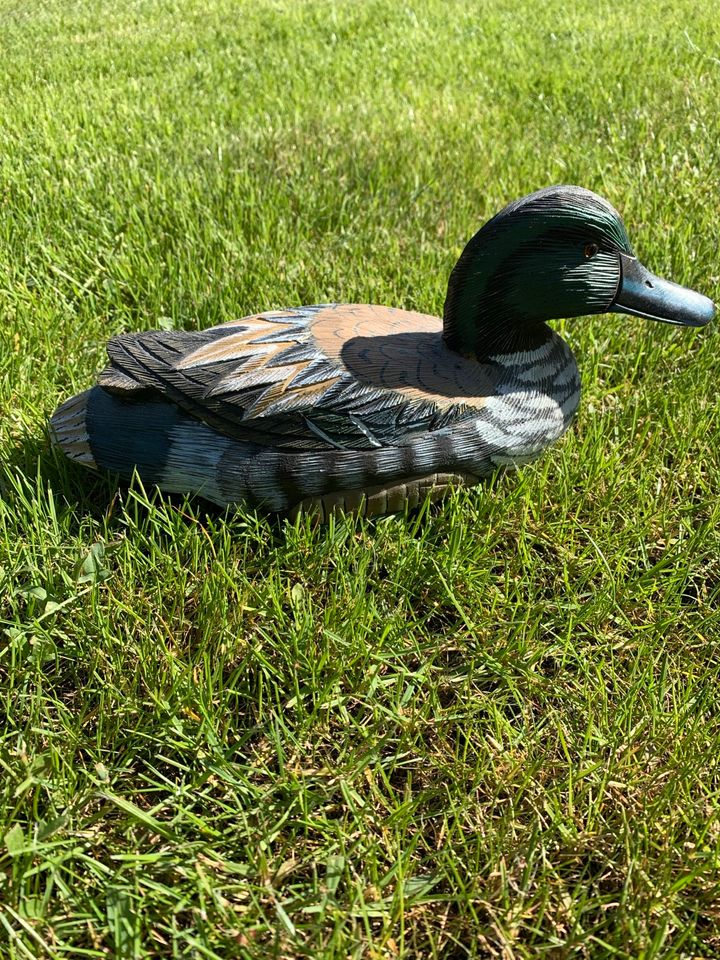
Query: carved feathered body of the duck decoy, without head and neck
53,304,579,512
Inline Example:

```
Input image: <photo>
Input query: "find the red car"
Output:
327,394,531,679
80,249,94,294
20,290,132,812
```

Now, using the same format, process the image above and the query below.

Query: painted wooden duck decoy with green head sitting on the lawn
51,186,715,515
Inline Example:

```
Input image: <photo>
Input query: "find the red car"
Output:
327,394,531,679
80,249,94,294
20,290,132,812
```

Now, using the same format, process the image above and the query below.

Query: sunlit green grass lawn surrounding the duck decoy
0,0,720,960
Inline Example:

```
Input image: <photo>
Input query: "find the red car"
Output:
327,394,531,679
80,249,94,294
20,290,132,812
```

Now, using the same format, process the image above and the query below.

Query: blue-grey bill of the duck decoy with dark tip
610,253,715,327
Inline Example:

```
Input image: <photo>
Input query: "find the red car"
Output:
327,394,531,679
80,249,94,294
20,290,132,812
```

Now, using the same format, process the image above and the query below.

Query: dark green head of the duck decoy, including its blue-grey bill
443,186,715,356
